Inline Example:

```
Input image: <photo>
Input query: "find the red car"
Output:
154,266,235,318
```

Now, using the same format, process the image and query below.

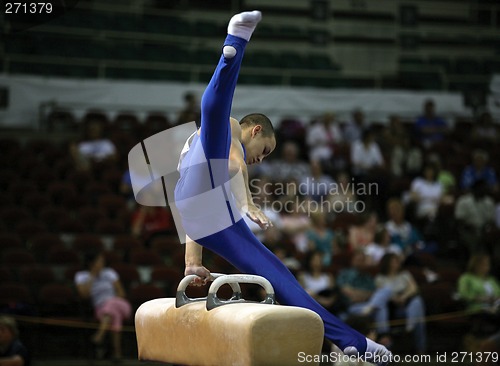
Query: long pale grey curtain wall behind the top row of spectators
0,74,472,128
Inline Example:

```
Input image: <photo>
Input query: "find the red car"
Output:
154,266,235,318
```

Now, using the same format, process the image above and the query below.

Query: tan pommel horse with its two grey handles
135,273,324,366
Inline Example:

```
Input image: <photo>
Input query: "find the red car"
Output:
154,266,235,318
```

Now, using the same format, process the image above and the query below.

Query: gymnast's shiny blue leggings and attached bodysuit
175,35,367,354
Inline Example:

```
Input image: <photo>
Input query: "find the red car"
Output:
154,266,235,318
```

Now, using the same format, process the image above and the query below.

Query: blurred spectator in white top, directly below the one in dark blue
410,163,444,221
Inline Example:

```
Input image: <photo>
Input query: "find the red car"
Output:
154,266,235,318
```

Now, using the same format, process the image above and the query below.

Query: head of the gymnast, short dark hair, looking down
240,113,276,165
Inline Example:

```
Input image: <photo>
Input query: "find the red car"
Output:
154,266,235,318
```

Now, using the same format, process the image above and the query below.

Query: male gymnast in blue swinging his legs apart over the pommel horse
175,11,391,364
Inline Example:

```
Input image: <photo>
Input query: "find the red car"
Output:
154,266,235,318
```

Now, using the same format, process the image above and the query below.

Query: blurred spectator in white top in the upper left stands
70,120,118,170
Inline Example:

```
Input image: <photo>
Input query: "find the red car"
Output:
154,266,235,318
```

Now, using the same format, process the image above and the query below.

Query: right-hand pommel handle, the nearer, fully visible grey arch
207,274,276,310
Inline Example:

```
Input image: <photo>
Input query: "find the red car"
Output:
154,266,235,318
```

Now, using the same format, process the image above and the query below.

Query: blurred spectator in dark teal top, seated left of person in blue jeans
337,250,392,334
